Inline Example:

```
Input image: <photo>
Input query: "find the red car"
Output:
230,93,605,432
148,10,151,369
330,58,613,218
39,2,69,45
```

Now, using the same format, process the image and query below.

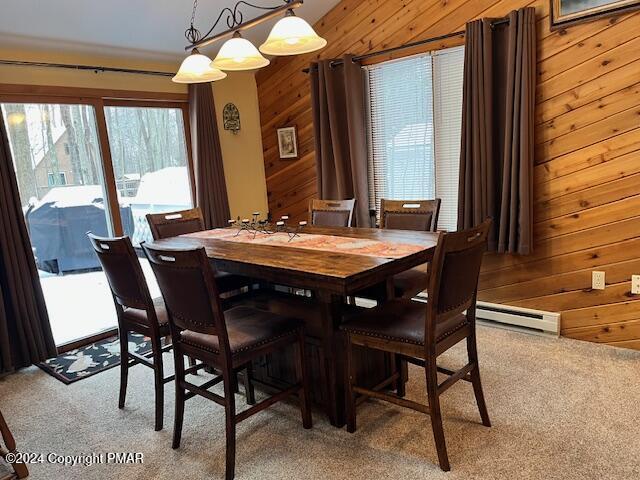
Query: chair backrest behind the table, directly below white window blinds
380,198,440,232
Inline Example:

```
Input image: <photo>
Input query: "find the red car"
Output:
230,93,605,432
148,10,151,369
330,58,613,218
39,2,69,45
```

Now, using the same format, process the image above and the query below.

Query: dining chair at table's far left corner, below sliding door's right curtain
147,207,254,293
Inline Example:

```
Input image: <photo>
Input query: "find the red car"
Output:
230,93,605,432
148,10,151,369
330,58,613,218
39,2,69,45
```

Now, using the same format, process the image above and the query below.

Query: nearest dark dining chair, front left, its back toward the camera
142,244,312,480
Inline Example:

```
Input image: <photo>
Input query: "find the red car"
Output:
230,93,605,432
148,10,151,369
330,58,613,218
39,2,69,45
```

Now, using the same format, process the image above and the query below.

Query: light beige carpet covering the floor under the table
0,327,640,480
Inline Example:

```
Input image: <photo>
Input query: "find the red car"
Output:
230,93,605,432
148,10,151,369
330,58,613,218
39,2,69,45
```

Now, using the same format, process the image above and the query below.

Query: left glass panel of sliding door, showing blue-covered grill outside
2,103,119,344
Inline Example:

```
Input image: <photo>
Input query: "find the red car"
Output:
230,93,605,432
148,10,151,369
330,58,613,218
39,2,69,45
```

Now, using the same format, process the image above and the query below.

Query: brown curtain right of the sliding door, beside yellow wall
189,83,231,229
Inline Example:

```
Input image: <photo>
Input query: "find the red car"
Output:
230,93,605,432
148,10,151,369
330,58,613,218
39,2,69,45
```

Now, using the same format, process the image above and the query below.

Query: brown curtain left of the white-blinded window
310,55,371,227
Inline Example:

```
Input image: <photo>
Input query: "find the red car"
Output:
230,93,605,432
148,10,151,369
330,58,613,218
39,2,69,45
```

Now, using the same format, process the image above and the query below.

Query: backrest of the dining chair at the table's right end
425,219,491,347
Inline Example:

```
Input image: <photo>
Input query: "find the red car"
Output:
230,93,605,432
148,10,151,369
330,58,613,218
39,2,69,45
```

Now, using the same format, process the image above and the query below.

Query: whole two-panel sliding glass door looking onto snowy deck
0,96,193,345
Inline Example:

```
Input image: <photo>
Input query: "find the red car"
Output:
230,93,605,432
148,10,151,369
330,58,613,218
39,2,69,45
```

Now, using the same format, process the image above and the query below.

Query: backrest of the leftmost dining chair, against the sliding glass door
87,232,153,310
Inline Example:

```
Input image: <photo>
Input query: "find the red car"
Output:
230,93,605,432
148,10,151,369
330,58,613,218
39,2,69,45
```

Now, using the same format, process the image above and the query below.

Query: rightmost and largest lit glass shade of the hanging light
260,14,327,55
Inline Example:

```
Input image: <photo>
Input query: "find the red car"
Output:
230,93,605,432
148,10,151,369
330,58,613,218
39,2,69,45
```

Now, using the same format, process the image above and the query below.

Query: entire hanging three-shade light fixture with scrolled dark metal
173,0,327,83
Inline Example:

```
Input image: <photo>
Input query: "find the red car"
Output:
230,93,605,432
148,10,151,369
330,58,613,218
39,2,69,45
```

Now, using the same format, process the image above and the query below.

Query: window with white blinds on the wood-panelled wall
367,47,464,230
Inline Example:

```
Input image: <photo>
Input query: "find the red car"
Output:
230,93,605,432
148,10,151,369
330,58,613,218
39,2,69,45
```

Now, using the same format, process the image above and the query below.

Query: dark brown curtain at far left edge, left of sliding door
0,115,57,373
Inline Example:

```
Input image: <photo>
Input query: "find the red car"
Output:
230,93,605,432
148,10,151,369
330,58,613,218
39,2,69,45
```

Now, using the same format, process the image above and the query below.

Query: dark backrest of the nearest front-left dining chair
142,248,229,353
